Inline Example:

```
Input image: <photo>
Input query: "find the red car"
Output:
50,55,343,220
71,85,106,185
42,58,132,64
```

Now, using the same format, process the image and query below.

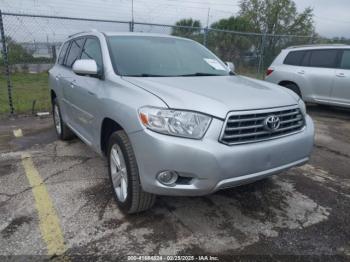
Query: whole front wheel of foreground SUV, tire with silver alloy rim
107,131,156,214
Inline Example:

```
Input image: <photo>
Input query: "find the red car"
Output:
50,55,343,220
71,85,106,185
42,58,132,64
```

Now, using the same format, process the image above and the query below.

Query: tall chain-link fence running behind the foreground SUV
0,13,348,114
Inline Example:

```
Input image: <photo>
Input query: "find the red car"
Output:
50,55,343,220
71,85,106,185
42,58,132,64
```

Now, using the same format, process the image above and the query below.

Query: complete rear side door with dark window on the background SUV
304,49,337,101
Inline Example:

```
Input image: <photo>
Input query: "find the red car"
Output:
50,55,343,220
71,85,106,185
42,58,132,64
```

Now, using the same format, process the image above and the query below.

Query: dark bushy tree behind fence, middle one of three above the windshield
208,16,254,66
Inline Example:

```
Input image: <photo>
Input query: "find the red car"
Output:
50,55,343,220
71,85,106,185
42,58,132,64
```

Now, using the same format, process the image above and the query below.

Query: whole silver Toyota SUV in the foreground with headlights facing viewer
49,31,314,213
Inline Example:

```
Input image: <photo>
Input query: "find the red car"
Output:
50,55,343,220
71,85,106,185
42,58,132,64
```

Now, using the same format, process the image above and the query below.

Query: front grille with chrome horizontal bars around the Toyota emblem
220,107,305,145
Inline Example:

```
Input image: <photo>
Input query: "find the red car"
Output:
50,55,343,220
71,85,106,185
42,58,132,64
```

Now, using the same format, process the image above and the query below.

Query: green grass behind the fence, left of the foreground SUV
0,73,50,114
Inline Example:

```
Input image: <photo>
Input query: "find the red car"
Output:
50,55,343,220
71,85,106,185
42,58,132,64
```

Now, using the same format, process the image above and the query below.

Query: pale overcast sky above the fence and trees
0,0,350,38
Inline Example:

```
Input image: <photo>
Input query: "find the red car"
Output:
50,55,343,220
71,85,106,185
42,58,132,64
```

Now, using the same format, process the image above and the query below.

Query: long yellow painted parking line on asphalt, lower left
22,154,67,256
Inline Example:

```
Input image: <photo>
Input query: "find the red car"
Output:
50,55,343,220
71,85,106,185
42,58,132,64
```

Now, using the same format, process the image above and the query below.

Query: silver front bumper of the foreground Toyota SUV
129,116,314,196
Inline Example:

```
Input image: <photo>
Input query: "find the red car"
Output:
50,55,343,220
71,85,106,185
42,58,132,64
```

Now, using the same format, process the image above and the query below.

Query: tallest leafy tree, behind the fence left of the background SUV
240,0,315,66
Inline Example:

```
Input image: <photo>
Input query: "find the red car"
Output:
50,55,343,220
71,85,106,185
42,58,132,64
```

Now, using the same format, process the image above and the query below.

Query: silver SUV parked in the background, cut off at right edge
266,45,350,107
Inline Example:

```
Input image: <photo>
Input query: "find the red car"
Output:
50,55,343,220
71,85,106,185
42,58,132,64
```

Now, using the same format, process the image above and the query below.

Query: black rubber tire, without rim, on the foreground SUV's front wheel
107,131,156,214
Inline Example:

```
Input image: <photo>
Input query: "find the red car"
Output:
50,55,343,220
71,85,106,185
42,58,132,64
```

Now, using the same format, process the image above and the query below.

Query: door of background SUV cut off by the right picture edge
332,49,350,106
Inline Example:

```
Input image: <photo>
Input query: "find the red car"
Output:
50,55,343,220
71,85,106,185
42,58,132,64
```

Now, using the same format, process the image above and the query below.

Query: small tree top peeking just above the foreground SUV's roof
171,18,202,39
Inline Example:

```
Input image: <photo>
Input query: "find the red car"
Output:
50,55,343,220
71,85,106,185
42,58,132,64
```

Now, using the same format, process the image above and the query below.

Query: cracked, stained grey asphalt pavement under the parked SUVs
0,106,350,261
